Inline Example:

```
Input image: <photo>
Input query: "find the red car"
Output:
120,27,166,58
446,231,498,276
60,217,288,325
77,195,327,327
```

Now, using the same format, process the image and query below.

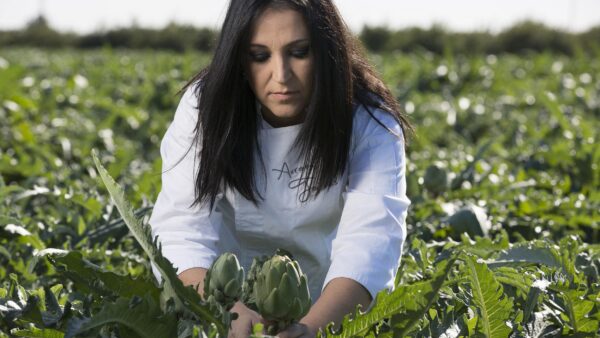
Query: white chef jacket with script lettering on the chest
150,87,410,303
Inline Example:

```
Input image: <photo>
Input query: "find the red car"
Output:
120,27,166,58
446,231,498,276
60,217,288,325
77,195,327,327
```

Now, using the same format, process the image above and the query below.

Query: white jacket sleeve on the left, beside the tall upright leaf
149,86,222,282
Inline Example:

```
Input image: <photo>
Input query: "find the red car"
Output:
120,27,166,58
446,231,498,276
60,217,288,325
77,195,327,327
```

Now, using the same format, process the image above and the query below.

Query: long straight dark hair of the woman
183,0,412,210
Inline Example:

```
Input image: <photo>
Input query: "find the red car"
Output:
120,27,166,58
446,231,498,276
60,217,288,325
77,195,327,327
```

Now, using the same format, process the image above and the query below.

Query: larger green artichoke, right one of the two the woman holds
254,254,311,333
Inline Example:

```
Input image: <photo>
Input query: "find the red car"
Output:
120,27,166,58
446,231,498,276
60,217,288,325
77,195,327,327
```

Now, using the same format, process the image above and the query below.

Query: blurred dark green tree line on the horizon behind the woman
0,16,600,55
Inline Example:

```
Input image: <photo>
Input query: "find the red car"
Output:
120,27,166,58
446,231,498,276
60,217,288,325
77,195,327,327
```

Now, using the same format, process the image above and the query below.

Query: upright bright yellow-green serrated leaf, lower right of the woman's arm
466,257,513,338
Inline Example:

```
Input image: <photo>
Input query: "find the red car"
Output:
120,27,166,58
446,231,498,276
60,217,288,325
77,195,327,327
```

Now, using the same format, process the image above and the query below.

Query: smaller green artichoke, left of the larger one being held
204,252,244,310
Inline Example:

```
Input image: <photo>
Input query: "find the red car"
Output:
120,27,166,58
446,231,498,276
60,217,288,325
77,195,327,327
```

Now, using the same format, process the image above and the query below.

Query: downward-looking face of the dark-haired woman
246,8,313,128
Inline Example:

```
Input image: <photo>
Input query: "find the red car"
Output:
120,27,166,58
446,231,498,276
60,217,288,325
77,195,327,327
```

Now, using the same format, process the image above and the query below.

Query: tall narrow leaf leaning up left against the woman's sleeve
92,151,225,336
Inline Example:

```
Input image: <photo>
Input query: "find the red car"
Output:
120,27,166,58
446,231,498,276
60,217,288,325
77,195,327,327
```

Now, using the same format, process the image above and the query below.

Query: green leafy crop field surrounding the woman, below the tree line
0,49,600,337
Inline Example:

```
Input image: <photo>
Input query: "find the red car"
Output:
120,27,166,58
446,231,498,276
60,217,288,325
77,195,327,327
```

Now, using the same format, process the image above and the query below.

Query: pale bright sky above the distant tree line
0,0,600,33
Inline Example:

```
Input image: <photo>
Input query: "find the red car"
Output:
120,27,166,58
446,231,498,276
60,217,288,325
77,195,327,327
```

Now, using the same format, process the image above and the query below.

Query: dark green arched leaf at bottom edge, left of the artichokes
65,294,177,338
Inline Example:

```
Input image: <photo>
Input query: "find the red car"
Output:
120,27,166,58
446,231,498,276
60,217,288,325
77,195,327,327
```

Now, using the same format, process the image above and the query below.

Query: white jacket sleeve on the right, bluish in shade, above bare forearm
323,105,410,299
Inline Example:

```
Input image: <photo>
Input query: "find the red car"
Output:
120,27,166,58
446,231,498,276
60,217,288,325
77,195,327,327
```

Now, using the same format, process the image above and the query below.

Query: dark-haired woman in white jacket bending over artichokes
150,0,411,337
